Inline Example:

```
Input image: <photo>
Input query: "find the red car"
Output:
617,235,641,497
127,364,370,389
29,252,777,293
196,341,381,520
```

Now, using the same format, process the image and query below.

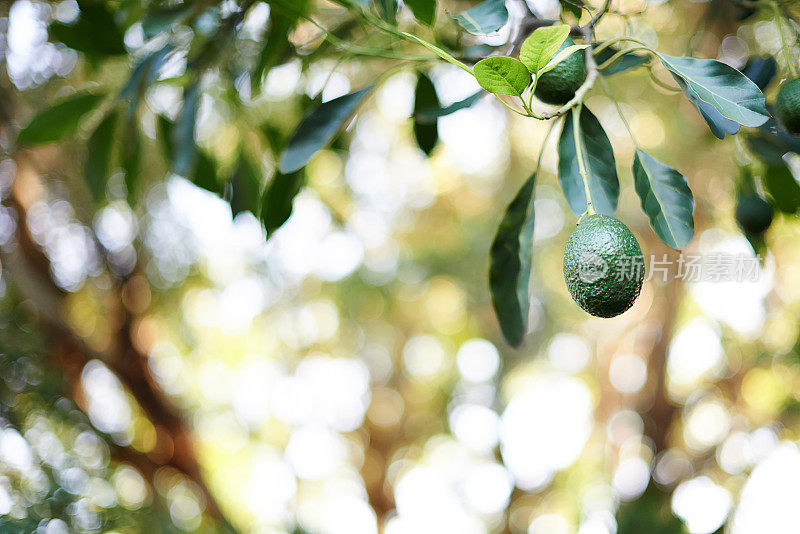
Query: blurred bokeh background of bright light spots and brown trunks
0,0,800,534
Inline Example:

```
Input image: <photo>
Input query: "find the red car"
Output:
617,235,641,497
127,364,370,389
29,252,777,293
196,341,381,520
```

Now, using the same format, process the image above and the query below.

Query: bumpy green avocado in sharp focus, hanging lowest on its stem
564,214,645,317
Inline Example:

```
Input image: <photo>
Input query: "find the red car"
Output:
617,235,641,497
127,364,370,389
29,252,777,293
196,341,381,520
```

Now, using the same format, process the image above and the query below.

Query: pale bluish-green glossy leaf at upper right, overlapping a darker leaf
656,53,769,131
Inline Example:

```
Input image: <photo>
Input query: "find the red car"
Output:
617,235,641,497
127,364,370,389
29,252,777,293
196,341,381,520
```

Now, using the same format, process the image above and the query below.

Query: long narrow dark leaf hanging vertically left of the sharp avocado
489,173,536,347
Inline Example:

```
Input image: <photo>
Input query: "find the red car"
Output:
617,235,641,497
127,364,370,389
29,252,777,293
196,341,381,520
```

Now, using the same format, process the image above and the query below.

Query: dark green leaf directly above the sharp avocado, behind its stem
558,107,619,216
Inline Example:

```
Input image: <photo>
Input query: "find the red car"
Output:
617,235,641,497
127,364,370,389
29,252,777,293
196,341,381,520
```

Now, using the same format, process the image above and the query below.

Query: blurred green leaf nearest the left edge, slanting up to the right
17,93,104,146
